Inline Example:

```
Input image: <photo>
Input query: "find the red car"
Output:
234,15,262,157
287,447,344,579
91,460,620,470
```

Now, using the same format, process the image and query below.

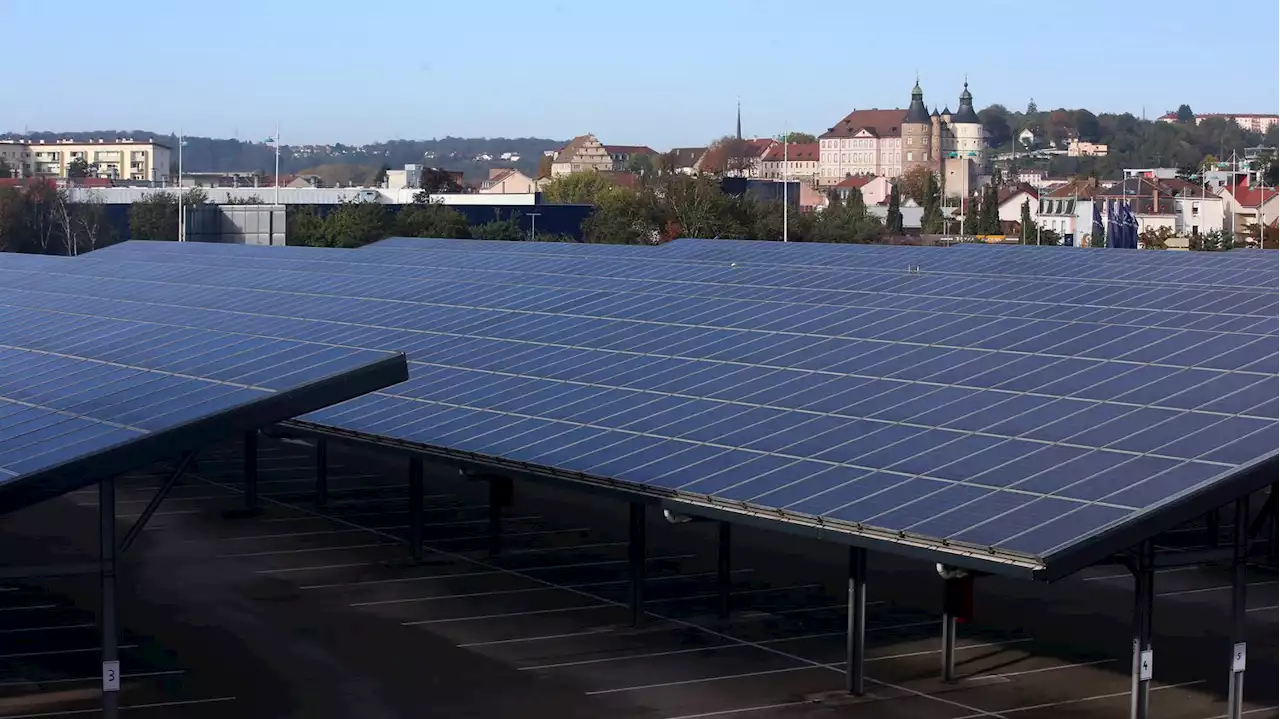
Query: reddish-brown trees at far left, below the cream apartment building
0,182,118,255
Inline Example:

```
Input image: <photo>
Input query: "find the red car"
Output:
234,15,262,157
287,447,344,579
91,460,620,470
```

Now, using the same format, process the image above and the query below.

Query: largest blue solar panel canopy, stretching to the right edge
4,241,1280,580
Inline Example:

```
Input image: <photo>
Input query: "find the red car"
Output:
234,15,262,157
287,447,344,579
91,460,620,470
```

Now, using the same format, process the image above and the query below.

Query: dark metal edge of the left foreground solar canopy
0,353,408,514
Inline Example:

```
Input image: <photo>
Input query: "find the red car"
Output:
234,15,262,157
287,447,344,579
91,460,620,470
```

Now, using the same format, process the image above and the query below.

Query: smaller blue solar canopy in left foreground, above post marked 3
0,255,406,512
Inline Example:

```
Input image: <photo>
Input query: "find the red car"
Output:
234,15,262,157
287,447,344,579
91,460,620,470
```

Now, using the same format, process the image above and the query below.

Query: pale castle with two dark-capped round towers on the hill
818,79,987,196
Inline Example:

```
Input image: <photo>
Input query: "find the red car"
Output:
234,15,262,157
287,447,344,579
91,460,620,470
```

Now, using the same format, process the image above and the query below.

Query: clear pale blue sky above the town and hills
0,0,1280,148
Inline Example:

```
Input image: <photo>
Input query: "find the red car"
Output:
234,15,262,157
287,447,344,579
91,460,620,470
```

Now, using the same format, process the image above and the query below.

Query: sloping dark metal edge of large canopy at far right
1038,454,1280,582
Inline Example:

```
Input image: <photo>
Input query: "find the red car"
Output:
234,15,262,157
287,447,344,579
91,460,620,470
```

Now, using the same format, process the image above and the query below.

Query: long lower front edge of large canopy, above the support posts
282,420,1044,578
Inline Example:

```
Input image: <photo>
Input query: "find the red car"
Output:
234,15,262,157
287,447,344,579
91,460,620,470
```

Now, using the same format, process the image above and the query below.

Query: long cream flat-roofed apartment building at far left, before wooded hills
0,138,172,184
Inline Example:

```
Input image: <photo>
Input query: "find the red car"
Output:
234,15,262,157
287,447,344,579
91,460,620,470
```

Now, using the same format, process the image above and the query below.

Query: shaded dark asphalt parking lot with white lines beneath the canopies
0,441,1280,719
